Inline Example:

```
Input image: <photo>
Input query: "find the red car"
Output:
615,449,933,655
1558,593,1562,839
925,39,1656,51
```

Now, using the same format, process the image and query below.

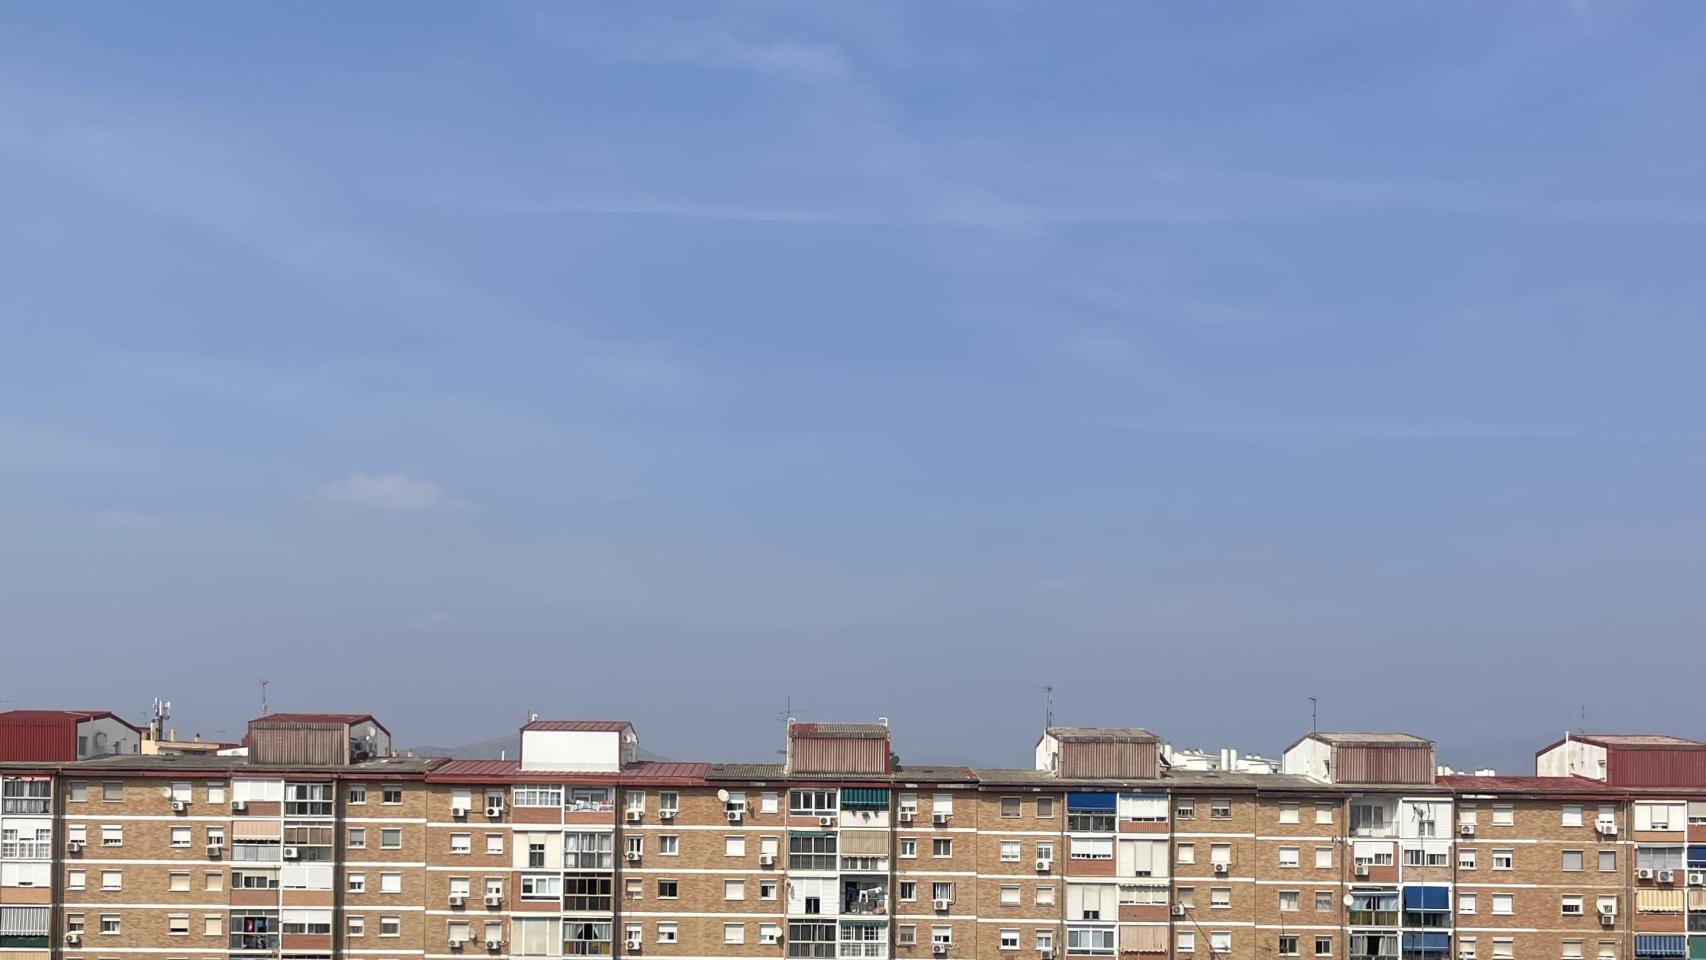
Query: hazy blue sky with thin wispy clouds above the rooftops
0,0,1706,762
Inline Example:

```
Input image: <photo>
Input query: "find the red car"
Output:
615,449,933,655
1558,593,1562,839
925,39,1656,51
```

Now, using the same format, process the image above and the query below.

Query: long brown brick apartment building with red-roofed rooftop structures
10,711,1706,960
